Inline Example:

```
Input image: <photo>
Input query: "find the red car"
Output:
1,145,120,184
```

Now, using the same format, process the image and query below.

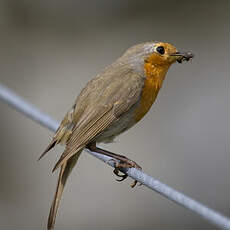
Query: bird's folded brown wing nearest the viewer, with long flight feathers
54,69,144,170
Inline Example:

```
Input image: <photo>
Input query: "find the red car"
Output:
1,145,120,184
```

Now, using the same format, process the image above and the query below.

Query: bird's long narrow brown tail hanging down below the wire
47,150,82,230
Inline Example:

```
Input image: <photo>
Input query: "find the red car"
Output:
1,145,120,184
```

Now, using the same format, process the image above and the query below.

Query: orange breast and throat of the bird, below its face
134,63,168,122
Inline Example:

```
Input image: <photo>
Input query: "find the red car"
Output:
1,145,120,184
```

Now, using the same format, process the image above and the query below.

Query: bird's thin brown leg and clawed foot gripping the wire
86,142,142,188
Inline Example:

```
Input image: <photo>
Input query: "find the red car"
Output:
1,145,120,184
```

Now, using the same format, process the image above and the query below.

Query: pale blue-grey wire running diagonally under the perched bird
0,84,230,230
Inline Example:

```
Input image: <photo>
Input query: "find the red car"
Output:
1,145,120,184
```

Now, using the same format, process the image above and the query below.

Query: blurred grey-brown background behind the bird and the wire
0,0,230,230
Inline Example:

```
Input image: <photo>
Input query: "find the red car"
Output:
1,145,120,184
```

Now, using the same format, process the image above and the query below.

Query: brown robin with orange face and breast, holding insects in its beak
39,41,193,230
